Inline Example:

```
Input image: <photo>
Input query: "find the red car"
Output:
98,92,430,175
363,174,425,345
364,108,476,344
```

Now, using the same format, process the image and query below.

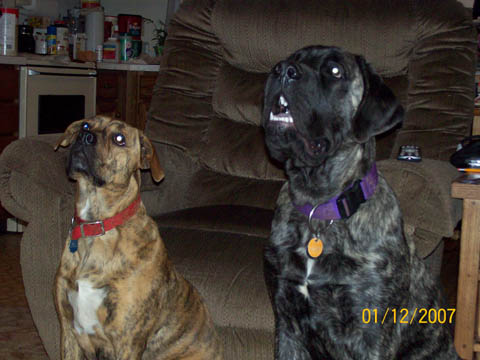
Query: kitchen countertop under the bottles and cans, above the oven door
0,53,160,72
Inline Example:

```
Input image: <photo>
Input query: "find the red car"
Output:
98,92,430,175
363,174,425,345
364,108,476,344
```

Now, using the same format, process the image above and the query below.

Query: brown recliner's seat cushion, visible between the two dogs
160,227,274,331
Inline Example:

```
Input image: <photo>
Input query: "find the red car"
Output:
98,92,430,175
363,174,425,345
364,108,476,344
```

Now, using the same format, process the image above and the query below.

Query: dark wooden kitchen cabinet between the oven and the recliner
97,69,157,130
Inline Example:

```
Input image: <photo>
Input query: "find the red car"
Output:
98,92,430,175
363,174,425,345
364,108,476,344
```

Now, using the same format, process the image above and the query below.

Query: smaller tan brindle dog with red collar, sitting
55,117,222,360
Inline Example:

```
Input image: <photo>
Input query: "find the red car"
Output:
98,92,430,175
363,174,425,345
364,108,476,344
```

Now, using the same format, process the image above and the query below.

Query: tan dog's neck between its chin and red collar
75,177,140,221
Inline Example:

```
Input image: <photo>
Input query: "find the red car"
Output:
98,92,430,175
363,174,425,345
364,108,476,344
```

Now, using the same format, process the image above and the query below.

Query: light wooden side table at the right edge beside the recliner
452,179,480,360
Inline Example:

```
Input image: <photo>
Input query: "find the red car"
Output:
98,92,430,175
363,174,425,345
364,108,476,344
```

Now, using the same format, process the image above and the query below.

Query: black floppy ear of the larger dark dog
352,56,404,143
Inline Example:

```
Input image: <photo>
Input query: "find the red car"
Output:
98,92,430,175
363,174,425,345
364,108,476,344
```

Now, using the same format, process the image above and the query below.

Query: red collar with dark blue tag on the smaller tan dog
70,194,141,252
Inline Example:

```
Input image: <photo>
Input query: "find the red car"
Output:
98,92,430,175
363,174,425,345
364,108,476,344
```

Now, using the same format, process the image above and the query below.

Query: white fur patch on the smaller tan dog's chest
68,280,106,335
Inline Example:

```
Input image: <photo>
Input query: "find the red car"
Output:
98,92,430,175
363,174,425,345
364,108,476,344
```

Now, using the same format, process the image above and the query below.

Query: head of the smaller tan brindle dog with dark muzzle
55,116,164,186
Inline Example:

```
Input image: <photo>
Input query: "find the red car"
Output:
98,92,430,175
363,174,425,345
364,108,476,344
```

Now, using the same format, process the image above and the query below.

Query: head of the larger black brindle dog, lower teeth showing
262,46,403,166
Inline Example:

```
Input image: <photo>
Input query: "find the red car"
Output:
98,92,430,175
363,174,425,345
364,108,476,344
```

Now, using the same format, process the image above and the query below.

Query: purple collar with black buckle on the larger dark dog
295,163,378,220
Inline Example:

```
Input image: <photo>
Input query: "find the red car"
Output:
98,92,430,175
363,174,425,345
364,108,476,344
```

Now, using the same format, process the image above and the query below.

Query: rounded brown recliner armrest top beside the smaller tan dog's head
0,135,75,222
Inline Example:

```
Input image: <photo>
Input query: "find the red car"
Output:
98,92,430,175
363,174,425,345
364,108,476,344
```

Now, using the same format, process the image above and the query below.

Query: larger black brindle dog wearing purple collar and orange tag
263,47,458,360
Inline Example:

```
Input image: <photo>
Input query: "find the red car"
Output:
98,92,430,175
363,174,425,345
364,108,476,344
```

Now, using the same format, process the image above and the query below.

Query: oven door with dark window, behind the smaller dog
19,66,97,137
